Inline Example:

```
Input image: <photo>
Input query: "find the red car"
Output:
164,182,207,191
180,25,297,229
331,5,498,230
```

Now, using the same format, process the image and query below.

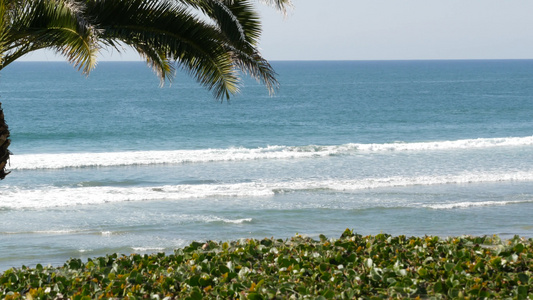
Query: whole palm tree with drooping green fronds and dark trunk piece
0,0,291,179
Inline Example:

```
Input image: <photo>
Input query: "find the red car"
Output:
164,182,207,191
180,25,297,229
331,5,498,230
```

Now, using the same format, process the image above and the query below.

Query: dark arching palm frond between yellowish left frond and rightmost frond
87,0,240,99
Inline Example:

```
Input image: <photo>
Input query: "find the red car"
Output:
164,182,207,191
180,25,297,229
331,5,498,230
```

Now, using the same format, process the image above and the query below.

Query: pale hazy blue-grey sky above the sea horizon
18,0,533,61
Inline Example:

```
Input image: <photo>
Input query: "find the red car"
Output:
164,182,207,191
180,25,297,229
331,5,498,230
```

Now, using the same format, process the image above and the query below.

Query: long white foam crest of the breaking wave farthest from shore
10,136,533,170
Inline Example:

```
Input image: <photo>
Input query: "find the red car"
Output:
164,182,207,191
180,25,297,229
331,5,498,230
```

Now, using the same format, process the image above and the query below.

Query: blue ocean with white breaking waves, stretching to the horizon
0,60,533,271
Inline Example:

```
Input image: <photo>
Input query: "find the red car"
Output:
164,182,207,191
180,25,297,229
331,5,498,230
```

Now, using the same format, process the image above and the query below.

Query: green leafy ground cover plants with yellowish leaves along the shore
0,230,533,300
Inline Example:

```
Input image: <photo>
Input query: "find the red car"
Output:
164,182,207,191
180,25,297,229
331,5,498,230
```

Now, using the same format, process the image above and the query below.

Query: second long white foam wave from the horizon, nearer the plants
4,171,533,210
